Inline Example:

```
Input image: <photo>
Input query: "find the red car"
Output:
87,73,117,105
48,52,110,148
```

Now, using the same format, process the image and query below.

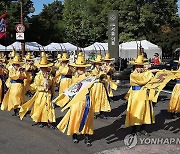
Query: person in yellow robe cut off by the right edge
168,58,180,118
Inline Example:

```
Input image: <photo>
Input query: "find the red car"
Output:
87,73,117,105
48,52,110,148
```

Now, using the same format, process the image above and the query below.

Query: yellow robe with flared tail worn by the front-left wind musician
19,71,56,122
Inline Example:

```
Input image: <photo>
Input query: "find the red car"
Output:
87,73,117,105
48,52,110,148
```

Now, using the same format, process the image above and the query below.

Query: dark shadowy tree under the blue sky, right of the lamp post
27,1,65,45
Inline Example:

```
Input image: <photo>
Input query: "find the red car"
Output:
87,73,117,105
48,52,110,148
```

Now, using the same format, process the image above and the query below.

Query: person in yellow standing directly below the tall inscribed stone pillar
102,53,117,97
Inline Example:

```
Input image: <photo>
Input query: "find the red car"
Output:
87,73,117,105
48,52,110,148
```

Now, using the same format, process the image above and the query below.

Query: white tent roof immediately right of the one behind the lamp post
44,42,78,51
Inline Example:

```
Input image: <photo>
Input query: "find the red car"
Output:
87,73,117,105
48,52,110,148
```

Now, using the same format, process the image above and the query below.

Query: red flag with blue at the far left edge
0,13,7,39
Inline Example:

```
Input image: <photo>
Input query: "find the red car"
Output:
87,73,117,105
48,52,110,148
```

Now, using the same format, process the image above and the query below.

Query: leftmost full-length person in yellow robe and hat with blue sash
1,54,26,116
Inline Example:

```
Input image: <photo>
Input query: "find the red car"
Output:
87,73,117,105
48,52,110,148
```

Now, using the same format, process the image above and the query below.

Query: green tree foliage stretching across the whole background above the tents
0,0,180,54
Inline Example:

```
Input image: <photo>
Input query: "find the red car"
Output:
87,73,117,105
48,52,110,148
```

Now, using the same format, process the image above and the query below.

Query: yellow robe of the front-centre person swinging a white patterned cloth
57,75,94,135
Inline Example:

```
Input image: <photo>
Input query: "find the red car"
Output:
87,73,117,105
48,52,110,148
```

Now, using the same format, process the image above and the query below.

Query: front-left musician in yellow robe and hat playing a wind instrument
19,56,56,129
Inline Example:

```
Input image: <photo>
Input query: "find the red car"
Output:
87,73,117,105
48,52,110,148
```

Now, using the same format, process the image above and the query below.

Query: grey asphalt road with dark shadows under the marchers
0,83,180,154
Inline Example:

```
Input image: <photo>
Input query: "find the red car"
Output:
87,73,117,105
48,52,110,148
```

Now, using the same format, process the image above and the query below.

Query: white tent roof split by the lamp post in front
6,42,43,51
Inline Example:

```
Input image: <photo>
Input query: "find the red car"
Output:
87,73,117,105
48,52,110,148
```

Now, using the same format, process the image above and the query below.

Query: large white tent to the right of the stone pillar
119,40,162,58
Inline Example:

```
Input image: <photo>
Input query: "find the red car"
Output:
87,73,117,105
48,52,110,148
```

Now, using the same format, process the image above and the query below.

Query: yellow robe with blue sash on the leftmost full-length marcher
1,69,26,111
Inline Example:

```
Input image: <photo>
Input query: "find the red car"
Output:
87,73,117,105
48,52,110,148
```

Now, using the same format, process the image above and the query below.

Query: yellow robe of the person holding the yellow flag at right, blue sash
125,70,155,127
